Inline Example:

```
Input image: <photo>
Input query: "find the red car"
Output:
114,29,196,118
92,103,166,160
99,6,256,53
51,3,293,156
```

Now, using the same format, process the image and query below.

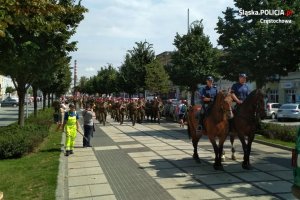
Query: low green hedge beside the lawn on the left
0,109,53,159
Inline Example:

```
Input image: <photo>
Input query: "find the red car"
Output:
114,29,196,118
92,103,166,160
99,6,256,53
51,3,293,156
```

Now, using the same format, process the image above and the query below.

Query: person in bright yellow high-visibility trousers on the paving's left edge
63,104,79,156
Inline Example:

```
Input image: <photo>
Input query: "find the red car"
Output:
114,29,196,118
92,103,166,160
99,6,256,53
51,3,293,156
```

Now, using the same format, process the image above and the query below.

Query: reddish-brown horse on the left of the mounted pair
187,91,233,170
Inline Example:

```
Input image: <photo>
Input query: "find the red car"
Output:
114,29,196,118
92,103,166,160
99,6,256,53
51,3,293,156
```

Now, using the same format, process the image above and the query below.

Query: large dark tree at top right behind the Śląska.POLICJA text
216,0,300,88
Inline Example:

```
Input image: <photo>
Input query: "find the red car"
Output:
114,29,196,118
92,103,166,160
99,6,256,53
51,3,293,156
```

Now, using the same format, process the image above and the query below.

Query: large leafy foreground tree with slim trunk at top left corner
0,0,87,126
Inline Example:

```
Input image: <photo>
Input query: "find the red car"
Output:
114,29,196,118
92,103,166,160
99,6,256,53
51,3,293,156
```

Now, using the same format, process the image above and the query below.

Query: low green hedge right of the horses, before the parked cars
258,123,297,142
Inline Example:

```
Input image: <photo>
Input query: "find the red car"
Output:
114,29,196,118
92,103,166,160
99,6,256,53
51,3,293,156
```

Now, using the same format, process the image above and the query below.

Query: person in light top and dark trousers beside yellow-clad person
82,104,94,148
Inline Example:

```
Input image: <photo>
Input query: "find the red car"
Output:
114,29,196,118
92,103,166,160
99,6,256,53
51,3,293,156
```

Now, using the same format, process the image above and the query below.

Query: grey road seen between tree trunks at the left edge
0,103,42,126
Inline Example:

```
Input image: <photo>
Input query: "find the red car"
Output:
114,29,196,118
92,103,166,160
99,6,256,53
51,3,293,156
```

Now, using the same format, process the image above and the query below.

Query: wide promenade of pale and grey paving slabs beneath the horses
57,112,295,200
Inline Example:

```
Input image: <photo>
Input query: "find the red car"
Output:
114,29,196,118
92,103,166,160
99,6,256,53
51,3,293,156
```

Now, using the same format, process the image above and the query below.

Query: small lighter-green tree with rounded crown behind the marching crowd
145,60,170,94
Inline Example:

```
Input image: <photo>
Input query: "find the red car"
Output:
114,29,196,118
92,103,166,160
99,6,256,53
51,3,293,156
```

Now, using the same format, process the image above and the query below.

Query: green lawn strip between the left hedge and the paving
0,125,61,200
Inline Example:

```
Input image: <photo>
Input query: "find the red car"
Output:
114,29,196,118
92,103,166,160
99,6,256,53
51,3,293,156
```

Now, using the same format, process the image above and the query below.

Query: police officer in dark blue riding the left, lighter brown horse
198,76,218,130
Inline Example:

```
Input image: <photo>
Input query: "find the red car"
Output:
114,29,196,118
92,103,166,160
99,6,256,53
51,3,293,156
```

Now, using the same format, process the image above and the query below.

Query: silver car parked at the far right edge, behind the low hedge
277,103,300,121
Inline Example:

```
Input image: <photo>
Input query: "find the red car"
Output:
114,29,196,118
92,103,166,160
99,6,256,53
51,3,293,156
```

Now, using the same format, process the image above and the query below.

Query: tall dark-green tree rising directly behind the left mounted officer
167,20,217,105
